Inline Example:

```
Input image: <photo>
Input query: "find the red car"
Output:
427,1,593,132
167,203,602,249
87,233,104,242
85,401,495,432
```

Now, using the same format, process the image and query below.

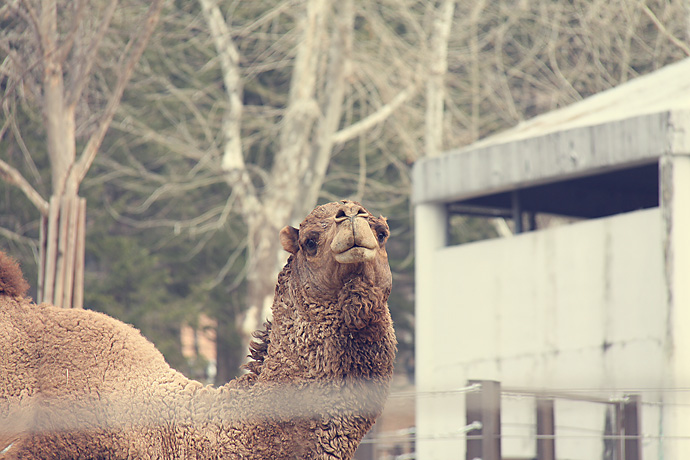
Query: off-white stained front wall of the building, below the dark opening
416,209,670,460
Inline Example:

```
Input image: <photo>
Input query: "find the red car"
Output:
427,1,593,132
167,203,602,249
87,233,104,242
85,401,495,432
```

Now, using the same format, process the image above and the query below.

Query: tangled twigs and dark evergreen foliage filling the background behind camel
0,0,690,380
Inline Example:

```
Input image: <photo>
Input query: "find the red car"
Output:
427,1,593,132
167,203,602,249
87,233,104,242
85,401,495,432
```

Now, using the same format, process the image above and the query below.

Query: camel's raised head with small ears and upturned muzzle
280,200,392,318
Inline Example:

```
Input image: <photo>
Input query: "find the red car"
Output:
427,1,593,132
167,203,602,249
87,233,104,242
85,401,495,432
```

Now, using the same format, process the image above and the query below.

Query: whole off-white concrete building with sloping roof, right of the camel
413,59,690,460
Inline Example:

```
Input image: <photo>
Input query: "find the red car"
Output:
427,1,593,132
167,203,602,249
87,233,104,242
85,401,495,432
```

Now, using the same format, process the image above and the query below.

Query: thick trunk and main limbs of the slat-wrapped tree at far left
28,0,163,308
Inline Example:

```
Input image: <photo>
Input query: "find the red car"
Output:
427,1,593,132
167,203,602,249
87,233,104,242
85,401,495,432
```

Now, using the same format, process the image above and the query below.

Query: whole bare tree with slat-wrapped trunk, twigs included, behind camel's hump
0,0,163,307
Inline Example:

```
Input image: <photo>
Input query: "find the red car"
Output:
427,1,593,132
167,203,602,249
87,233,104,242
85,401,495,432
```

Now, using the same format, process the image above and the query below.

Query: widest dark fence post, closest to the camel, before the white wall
465,380,501,460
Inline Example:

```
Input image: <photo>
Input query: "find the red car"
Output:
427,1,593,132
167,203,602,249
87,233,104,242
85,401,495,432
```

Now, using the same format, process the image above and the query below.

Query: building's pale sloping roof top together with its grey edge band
413,58,690,203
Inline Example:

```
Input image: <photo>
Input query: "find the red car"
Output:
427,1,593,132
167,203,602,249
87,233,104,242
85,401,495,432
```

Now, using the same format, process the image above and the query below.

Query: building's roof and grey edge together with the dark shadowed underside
412,59,690,218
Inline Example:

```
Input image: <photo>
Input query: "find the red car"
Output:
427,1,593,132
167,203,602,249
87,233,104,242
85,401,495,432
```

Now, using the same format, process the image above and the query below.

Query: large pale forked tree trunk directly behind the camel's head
200,0,432,342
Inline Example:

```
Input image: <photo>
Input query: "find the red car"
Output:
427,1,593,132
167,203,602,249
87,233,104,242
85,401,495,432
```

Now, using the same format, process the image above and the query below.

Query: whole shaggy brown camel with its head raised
0,201,396,459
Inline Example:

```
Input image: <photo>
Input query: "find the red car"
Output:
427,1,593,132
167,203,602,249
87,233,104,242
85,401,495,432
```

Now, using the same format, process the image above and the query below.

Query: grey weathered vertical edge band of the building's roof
412,110,690,204
